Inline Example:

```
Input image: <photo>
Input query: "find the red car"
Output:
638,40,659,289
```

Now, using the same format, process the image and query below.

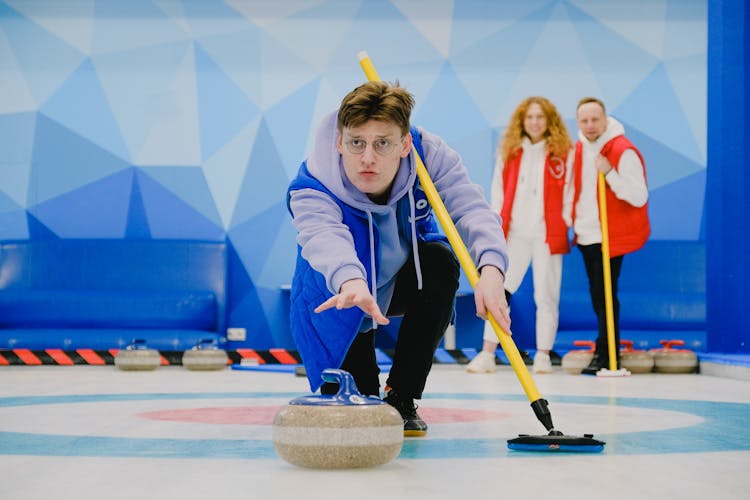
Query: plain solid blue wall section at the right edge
706,0,750,353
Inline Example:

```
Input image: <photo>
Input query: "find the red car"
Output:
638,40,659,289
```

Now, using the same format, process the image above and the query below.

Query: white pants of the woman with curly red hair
484,233,562,350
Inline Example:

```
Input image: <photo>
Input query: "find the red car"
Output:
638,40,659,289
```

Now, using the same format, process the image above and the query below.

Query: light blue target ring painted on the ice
0,392,750,459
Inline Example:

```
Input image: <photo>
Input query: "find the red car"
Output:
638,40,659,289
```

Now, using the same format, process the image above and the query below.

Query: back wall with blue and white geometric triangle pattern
0,0,707,348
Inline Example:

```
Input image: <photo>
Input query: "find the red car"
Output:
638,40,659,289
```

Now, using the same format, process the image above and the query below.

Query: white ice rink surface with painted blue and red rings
0,364,750,500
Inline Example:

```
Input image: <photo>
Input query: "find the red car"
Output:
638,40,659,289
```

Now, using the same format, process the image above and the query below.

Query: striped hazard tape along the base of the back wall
0,348,531,366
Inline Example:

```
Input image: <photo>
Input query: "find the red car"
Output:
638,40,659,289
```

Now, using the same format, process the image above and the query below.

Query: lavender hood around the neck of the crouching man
307,110,417,213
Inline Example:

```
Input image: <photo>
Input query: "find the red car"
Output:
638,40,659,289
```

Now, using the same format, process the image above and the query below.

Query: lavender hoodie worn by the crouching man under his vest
289,111,508,324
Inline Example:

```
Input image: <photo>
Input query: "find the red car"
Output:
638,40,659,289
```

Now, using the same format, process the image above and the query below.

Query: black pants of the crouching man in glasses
321,242,459,399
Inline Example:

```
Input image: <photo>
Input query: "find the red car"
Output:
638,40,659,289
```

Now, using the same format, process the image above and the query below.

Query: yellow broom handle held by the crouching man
358,52,541,403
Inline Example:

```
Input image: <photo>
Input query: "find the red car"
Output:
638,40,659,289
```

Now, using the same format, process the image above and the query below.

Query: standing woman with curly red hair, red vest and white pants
466,97,572,373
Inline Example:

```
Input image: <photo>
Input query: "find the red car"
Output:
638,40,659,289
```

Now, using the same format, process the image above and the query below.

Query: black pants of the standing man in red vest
578,243,623,363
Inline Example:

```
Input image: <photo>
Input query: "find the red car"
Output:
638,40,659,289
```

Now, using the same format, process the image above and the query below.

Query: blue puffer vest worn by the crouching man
287,127,447,392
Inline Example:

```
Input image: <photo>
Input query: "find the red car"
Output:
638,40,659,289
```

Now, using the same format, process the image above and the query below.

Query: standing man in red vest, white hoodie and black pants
571,97,651,375
